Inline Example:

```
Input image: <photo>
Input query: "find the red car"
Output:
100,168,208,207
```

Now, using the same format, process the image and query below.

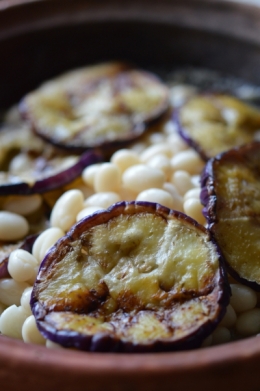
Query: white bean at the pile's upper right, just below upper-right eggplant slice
171,149,205,175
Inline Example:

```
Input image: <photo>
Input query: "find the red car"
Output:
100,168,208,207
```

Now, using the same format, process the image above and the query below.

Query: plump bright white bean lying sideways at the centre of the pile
122,164,165,193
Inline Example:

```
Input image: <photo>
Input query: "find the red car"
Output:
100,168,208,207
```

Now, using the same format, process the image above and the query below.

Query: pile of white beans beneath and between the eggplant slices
0,86,260,347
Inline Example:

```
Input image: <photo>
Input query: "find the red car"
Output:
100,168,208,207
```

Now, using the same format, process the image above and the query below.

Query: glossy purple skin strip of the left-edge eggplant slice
0,151,104,196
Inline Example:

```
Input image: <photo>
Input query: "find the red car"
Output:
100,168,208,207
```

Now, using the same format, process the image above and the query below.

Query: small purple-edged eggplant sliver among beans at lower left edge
0,234,38,278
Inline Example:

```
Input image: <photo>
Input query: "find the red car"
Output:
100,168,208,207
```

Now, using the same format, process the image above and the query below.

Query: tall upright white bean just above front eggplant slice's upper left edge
50,190,84,231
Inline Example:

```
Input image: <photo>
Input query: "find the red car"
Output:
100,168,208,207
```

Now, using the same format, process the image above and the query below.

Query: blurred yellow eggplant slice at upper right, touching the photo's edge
174,94,260,160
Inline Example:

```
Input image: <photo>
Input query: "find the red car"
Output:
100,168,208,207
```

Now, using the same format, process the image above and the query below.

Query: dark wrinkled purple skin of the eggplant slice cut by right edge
200,142,260,292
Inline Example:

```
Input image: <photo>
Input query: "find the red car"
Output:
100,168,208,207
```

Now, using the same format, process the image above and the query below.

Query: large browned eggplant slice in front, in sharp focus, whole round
31,201,229,352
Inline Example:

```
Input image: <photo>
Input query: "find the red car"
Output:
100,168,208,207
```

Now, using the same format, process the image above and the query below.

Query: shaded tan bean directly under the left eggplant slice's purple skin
3,194,42,216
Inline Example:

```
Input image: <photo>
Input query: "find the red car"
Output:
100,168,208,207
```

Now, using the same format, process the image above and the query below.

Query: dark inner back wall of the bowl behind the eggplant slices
0,20,260,108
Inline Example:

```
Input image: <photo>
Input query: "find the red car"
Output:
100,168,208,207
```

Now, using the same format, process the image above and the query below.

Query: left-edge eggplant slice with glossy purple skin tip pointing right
0,123,103,195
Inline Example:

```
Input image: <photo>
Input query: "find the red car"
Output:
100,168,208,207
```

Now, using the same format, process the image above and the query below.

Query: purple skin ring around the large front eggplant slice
30,201,230,353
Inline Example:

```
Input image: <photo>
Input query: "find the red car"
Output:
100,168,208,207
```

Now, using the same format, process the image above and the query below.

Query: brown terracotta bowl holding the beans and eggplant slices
0,0,260,391
